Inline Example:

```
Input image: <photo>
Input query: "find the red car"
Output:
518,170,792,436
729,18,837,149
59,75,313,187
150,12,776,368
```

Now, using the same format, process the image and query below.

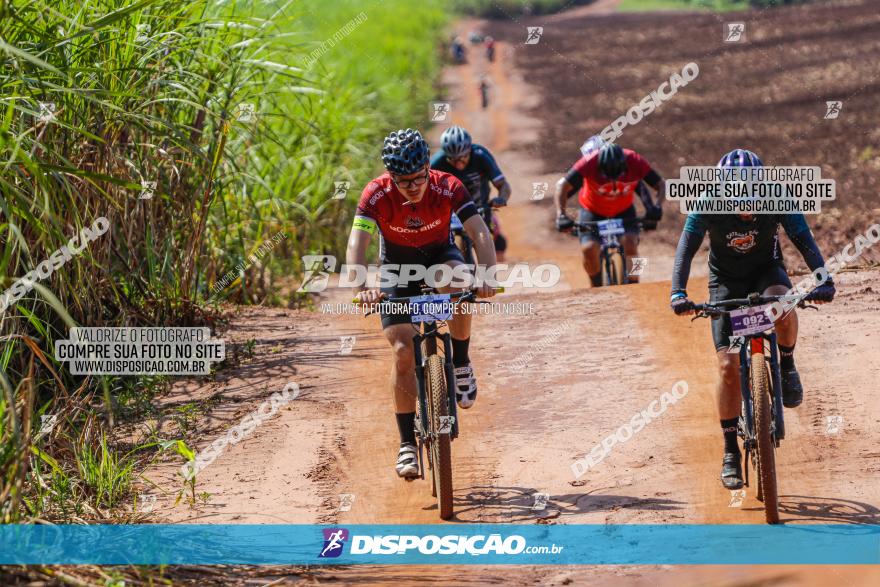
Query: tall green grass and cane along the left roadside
0,0,448,522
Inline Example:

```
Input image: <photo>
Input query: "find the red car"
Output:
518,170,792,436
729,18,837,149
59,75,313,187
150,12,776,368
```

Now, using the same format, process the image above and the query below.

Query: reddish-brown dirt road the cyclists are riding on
144,3,880,585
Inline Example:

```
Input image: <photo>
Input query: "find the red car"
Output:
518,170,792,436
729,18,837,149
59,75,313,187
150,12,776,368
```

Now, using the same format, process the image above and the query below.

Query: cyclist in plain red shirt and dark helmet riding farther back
554,141,666,287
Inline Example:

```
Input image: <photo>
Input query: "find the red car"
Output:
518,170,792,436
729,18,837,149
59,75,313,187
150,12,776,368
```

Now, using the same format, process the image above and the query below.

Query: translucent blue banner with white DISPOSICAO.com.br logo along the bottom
0,524,880,565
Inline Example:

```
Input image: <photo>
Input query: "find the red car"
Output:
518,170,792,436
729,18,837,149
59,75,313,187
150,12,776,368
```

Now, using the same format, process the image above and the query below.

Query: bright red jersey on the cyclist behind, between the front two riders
566,149,660,218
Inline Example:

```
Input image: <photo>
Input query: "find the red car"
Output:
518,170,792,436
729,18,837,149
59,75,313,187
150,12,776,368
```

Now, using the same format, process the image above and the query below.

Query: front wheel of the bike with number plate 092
750,350,779,524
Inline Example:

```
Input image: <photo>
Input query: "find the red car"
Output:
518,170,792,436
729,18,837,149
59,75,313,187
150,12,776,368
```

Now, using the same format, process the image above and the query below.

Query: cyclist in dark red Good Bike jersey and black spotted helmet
346,129,495,478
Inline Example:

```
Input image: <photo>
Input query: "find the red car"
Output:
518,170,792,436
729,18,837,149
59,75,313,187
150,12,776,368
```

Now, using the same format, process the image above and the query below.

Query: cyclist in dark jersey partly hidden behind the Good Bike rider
431,126,510,263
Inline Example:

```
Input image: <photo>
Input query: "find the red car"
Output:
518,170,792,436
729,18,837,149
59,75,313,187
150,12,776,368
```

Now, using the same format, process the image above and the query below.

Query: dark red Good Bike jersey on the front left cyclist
354,170,477,263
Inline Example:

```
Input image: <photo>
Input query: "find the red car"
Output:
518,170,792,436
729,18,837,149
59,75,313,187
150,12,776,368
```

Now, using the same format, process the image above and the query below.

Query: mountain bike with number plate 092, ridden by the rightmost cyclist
692,293,817,524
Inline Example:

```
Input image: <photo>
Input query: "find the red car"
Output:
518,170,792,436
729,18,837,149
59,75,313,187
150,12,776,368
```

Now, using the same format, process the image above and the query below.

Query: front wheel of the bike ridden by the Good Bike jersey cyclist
426,354,452,520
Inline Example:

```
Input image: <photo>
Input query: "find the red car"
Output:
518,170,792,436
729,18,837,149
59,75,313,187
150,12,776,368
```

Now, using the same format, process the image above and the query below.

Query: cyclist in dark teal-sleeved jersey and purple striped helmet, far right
671,149,835,489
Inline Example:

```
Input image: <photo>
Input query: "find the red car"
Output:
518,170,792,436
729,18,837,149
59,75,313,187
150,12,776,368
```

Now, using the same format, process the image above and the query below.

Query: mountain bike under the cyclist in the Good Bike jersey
367,286,484,520
